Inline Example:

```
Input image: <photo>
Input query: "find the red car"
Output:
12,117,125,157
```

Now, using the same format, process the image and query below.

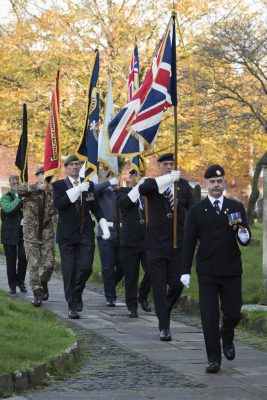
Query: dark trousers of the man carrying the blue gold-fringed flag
59,235,95,308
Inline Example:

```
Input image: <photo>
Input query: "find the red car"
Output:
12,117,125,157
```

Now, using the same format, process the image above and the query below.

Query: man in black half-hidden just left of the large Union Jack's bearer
117,168,151,318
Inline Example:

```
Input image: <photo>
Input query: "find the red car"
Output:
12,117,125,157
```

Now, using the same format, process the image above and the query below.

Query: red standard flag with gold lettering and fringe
44,71,60,182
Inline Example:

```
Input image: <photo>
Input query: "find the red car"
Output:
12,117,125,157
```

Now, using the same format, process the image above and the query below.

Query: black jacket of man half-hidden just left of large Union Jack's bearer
117,187,145,246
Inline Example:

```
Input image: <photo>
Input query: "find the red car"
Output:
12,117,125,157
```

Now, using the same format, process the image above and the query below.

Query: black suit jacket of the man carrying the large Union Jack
139,178,195,253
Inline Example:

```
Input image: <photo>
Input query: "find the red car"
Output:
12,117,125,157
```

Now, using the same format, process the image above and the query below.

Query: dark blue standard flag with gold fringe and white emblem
76,49,99,180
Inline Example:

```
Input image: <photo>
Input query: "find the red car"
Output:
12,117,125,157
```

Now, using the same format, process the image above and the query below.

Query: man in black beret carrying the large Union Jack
138,153,195,341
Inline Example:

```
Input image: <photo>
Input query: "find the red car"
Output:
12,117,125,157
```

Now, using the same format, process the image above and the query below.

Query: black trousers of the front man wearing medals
198,274,242,364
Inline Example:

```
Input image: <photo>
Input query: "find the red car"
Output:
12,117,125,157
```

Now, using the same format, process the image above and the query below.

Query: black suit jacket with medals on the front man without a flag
182,197,249,276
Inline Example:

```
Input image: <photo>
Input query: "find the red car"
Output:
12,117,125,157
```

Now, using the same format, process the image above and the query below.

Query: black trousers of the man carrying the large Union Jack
147,249,183,330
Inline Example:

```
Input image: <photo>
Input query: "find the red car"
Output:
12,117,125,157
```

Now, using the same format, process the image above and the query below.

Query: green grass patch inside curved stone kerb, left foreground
0,290,76,373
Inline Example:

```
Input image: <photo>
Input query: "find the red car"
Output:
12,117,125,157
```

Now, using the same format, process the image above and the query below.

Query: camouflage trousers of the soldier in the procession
24,240,55,291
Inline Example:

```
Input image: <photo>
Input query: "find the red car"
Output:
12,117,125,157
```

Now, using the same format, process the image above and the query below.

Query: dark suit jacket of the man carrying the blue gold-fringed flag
52,179,103,244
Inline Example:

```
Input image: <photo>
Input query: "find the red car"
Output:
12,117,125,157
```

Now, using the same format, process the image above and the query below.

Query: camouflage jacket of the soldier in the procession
17,183,56,243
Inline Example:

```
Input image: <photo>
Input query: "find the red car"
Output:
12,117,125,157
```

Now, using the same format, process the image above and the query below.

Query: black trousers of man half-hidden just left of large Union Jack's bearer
121,246,151,311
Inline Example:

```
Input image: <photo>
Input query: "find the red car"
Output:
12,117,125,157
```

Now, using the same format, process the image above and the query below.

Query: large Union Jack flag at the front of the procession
108,16,177,155
